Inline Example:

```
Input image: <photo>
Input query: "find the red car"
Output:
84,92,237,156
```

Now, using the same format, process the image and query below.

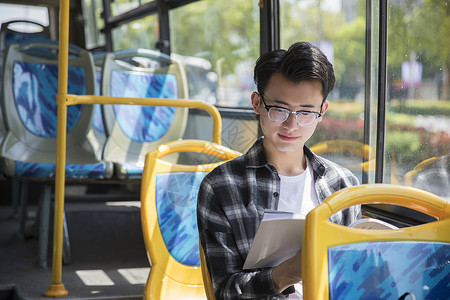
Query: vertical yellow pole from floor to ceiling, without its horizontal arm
44,0,70,297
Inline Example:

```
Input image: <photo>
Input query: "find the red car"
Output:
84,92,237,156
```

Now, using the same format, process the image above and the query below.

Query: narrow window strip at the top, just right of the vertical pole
83,0,105,49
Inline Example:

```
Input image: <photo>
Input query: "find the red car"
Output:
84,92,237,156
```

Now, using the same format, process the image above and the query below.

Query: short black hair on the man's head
254,42,336,101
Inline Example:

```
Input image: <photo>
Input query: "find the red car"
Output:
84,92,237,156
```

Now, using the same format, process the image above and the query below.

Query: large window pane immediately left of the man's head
170,0,259,107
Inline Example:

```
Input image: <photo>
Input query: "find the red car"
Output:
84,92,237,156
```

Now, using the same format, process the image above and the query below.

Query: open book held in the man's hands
243,210,398,270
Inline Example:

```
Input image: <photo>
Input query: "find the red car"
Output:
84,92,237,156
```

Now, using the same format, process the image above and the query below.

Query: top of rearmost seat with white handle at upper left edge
0,20,50,51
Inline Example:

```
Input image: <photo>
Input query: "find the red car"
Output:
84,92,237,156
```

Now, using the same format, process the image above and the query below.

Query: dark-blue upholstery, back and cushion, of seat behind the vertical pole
13,62,106,179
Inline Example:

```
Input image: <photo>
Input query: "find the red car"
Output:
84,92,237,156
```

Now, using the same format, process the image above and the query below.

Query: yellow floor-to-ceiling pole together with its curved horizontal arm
44,0,222,297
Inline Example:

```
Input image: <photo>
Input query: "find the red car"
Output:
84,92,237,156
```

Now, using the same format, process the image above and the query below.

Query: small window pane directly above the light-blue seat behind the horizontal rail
112,15,158,51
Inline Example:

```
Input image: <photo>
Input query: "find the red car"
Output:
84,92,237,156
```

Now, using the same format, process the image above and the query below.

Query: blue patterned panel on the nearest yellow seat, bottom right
328,241,450,300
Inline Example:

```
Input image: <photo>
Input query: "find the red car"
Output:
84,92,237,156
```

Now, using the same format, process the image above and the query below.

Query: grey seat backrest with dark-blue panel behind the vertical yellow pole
0,41,107,176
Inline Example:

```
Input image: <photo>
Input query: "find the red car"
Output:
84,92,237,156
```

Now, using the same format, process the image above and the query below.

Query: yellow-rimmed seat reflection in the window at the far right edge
405,153,450,201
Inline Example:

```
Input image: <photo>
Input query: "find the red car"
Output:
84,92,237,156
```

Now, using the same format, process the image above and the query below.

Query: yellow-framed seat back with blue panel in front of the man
302,184,450,300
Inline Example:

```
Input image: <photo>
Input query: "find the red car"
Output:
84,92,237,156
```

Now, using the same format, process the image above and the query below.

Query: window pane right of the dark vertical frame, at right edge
384,0,450,199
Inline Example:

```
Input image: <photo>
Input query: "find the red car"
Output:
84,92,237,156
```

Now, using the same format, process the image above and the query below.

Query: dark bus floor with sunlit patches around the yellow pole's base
0,185,150,300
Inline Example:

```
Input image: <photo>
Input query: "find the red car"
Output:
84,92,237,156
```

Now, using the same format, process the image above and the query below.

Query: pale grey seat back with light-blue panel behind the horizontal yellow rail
102,49,188,179
